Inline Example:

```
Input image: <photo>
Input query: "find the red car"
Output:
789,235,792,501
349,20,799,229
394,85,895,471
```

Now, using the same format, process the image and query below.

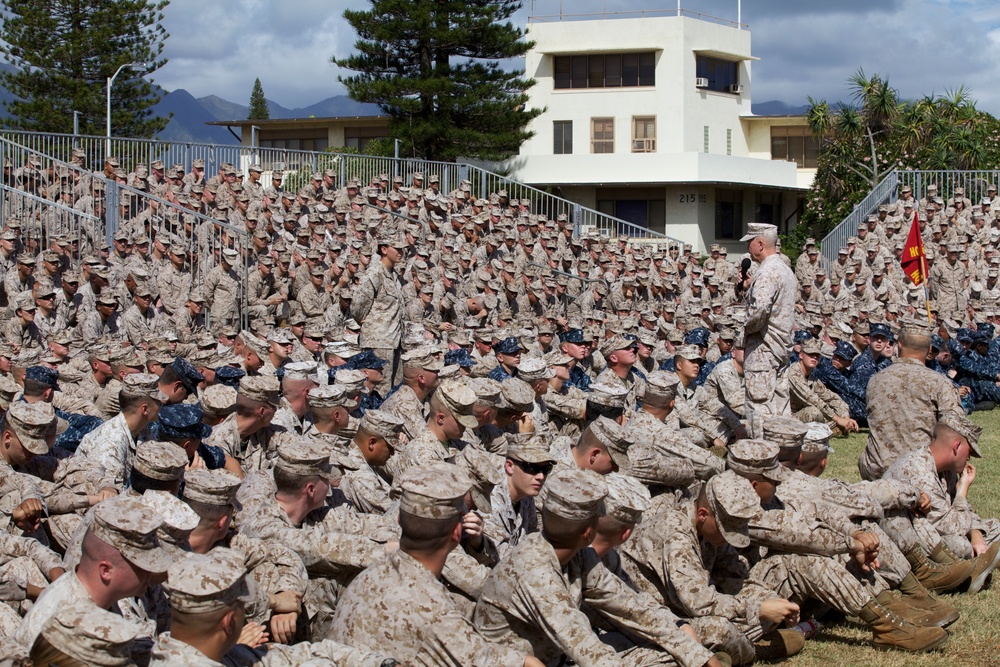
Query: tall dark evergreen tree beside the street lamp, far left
0,0,169,137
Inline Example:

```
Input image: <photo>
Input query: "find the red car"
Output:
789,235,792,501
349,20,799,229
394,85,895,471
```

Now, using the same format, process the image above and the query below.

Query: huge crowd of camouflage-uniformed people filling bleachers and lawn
0,154,1000,667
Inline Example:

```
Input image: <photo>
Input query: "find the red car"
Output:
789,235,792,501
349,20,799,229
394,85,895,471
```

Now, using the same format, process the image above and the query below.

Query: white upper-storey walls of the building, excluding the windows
521,17,751,158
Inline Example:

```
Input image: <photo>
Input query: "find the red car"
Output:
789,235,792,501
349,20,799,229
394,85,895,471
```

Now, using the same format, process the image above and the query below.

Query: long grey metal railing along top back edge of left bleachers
0,130,679,242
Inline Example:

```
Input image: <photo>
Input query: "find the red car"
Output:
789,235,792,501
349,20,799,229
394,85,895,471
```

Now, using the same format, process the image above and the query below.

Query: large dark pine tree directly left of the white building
332,0,542,160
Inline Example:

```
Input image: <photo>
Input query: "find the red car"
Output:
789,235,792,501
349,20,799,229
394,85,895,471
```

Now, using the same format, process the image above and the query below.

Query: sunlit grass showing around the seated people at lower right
778,406,1000,667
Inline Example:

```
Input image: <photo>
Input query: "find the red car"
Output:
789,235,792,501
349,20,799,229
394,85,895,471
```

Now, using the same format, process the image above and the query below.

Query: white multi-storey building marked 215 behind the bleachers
509,11,816,251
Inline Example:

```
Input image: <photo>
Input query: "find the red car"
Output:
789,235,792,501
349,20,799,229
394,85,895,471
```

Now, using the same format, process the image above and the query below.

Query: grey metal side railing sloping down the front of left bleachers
0,136,251,328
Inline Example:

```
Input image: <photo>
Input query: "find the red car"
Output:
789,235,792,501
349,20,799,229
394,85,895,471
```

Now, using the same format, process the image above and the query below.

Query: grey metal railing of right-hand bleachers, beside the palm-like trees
820,169,1000,263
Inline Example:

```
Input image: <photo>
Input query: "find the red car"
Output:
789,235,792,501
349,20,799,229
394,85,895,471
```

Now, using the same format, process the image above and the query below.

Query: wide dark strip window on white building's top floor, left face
552,51,656,90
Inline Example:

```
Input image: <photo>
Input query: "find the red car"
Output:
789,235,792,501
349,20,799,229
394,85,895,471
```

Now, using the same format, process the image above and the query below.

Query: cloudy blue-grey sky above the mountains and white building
155,0,1000,115
